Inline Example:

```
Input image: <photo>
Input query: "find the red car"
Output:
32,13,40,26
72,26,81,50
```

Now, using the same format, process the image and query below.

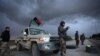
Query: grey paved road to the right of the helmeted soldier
66,40,99,56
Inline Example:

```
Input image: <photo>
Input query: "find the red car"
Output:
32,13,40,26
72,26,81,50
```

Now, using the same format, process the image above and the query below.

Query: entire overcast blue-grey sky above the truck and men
0,0,100,36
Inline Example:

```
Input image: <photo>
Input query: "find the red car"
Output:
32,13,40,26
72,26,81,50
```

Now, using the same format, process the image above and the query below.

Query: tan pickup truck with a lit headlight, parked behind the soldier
16,27,60,56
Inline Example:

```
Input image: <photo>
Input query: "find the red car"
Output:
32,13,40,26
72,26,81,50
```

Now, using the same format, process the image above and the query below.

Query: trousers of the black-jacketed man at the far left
0,42,10,56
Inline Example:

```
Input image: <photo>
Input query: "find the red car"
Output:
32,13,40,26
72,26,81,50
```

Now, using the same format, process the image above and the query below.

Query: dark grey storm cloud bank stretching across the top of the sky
0,0,100,24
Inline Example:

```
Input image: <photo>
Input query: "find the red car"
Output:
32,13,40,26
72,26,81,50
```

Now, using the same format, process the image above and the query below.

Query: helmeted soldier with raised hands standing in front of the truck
58,21,69,56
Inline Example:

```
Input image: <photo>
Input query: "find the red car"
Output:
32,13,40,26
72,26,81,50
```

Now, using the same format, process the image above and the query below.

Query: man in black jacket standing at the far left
1,27,10,56
